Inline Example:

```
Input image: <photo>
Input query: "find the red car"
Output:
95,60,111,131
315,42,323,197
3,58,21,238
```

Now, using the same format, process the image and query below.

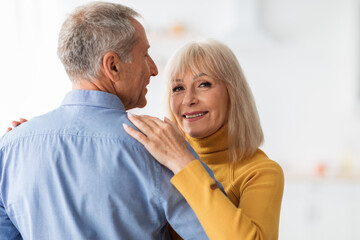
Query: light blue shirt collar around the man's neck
61,89,125,111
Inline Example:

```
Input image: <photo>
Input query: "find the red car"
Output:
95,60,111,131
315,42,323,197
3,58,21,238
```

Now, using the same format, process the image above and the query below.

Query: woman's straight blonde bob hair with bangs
165,40,264,162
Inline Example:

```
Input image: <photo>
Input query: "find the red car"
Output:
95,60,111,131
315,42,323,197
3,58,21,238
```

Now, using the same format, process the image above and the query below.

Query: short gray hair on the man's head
57,2,140,82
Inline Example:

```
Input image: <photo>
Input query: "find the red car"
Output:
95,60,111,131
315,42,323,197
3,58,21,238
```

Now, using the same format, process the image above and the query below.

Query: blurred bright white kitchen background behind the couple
0,0,360,240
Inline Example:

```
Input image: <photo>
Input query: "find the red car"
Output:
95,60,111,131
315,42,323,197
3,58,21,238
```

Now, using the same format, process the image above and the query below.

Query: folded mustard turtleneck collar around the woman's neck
186,124,228,155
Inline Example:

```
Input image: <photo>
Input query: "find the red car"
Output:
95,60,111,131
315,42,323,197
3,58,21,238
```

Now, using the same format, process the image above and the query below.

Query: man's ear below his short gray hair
102,52,122,82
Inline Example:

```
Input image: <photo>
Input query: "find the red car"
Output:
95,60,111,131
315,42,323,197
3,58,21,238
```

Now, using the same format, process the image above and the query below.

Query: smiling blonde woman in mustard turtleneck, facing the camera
124,40,284,240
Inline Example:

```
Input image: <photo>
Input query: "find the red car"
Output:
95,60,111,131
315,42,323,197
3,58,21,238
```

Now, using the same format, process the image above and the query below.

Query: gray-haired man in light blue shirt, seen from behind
0,2,212,240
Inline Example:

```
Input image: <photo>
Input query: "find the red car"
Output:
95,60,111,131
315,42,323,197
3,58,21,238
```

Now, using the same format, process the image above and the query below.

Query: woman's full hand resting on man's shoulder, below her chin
123,114,195,174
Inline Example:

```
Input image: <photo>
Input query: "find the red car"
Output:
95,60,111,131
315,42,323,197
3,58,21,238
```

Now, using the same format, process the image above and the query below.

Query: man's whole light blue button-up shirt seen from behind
0,90,213,240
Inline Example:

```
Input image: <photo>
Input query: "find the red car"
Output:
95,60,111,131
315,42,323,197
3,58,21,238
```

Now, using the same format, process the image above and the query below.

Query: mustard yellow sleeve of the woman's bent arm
171,161,284,240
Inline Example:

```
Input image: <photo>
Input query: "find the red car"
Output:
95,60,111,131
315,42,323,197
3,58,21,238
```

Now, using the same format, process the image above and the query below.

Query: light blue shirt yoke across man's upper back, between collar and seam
0,107,143,148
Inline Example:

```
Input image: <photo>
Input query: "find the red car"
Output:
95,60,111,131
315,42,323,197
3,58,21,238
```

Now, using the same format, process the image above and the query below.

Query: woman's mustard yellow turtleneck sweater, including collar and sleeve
171,126,284,240
